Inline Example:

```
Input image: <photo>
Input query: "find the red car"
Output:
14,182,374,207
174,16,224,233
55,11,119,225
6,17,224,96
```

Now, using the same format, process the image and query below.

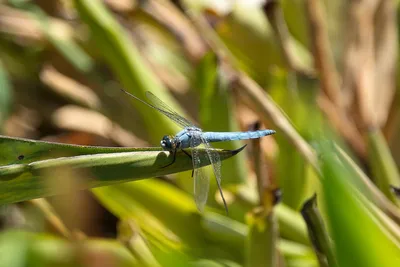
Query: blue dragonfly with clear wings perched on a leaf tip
121,89,275,214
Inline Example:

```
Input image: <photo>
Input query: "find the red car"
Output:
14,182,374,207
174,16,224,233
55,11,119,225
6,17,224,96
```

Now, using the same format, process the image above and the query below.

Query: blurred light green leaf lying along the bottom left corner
0,231,141,267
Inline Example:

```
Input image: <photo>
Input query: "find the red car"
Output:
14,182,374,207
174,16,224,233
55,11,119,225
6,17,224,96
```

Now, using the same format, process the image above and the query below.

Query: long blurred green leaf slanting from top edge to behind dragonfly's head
74,0,183,143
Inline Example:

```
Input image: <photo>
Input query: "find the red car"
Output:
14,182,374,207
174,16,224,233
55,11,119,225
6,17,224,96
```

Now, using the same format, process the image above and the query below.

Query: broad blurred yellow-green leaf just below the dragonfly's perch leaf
93,179,204,250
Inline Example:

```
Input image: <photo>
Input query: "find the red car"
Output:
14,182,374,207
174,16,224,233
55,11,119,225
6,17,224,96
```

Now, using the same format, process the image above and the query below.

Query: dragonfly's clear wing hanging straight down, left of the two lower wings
191,139,210,212
